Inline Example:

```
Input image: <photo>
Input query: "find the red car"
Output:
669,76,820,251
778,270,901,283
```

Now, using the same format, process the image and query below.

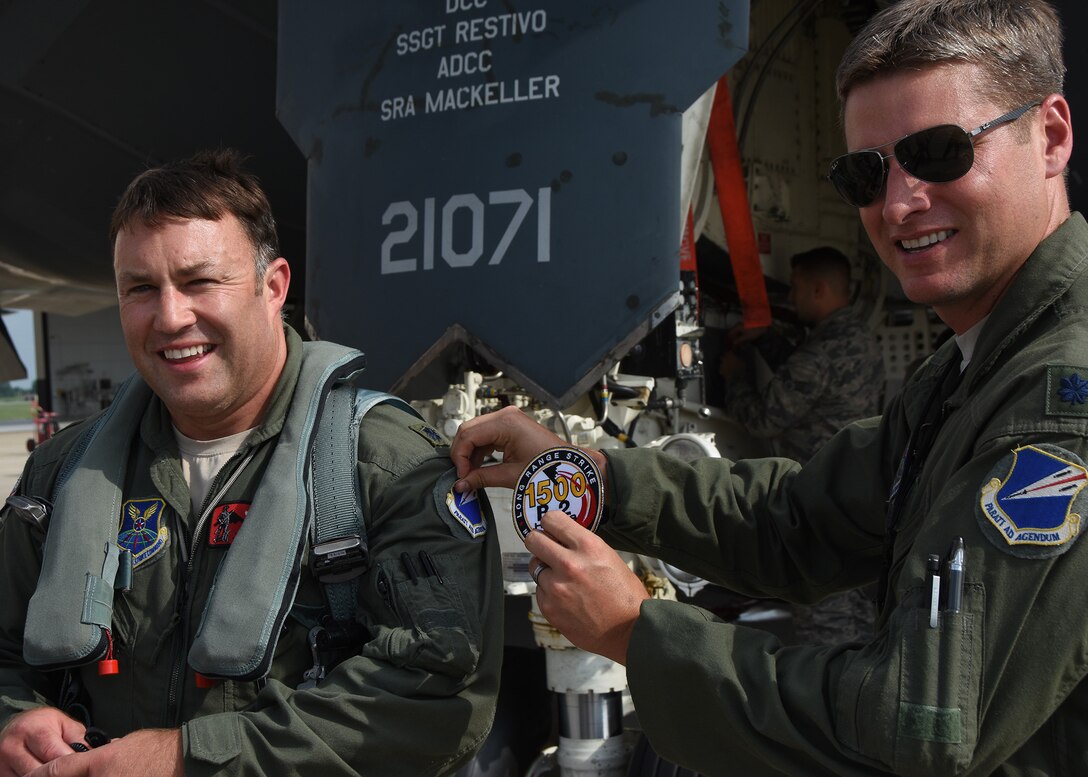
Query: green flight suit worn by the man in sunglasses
602,213,1088,777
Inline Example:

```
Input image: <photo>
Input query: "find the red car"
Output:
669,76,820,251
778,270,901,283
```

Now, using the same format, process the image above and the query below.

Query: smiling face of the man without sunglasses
114,213,290,440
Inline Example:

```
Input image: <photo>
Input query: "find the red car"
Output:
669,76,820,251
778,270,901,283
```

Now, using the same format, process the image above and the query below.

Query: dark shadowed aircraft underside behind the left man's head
0,0,306,316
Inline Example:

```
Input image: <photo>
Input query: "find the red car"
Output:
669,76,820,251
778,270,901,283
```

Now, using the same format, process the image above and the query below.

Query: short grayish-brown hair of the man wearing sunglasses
836,0,1065,108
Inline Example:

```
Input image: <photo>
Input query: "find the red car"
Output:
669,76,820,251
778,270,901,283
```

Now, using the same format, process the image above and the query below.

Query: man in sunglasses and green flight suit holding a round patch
452,0,1088,776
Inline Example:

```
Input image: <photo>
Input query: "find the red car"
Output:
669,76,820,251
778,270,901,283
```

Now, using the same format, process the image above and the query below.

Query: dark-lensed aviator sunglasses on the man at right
828,100,1041,208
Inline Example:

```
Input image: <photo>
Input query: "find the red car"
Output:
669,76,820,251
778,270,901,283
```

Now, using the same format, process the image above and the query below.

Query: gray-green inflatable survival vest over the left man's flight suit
23,343,418,680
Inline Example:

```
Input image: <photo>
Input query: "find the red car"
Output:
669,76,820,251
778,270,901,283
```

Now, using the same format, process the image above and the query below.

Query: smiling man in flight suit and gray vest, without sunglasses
0,150,503,777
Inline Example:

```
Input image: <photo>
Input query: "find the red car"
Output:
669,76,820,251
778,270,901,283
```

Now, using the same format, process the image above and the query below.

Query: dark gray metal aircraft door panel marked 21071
277,0,749,406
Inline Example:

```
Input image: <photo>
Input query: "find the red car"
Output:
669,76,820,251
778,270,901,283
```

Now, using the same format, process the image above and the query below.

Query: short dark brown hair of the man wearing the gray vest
110,148,280,280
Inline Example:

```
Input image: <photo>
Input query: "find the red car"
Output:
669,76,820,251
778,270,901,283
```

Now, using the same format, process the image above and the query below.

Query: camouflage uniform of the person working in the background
725,308,885,644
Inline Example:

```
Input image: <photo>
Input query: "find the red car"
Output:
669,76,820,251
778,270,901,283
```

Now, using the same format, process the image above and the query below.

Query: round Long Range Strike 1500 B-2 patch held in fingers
512,447,604,539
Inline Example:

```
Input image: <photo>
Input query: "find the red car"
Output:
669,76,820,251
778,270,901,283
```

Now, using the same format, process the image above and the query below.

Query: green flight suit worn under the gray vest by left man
0,330,503,777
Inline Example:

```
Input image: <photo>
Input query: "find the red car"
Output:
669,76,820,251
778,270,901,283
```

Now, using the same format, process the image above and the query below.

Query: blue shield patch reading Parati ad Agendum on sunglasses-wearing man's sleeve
977,445,1088,558
